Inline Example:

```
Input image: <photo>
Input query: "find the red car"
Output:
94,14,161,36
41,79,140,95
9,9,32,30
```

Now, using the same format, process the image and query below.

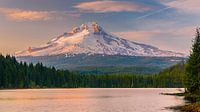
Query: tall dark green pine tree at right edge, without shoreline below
185,28,200,93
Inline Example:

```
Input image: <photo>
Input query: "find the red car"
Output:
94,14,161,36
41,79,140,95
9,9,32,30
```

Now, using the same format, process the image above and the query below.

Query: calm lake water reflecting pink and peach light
0,88,184,112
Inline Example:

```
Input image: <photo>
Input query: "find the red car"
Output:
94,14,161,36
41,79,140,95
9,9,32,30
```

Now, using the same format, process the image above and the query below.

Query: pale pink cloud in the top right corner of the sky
161,0,200,13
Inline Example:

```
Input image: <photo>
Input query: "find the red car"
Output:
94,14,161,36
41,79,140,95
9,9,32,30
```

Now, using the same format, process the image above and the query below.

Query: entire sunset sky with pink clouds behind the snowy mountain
0,0,200,54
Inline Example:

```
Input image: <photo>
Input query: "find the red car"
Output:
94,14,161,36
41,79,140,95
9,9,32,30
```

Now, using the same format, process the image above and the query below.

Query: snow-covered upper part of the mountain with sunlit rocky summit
16,22,184,57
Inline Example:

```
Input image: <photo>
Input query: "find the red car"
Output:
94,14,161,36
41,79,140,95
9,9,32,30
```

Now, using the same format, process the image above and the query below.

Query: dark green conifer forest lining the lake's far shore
0,55,185,89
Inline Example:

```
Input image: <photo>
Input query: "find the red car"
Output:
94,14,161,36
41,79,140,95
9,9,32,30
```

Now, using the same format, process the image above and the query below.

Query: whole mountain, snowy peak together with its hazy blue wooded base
15,22,186,74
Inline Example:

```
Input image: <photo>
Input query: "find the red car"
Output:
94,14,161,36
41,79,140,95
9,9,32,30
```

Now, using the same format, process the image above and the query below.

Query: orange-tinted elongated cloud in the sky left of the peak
0,8,79,21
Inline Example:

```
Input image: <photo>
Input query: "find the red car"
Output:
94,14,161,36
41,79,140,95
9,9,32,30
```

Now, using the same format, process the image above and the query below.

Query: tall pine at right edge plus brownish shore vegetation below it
182,28,200,112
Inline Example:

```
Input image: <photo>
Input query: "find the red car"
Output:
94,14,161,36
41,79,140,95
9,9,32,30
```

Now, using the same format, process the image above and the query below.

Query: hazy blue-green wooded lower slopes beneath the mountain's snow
17,54,185,74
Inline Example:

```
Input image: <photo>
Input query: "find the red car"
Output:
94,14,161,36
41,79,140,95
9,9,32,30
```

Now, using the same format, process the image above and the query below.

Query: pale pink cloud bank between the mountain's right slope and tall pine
113,26,195,54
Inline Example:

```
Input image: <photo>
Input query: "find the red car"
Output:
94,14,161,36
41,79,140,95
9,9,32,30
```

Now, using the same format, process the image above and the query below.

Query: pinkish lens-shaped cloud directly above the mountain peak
74,0,152,13
